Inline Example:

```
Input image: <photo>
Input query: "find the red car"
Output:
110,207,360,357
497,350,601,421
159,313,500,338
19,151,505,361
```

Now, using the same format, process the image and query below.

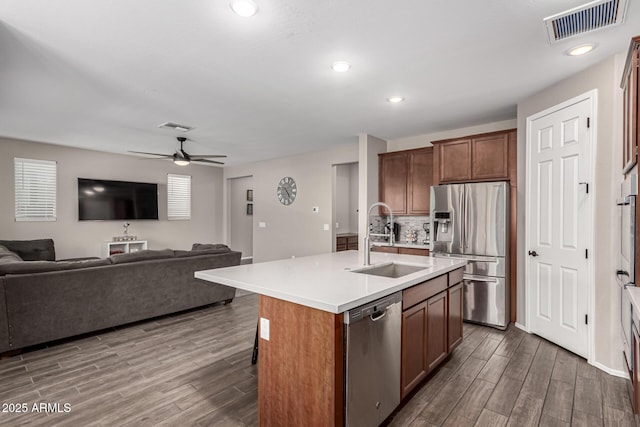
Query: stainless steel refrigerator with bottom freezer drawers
431,182,510,329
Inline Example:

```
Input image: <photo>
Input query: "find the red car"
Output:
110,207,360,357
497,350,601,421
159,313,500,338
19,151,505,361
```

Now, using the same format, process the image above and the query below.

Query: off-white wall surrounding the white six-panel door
517,56,622,372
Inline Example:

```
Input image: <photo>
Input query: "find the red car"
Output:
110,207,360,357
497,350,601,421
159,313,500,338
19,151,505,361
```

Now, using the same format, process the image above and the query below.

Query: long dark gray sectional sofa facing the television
0,240,241,353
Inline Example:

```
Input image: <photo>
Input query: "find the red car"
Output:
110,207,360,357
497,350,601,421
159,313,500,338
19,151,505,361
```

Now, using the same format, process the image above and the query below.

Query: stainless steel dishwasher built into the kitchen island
344,292,402,427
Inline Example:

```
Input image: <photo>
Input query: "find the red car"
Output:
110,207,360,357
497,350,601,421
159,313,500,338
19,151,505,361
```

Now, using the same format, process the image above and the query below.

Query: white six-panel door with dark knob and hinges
526,97,593,357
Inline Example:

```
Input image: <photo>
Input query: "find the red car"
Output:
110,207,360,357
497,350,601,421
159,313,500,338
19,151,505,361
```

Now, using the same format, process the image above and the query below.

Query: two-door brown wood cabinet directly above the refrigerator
433,130,516,184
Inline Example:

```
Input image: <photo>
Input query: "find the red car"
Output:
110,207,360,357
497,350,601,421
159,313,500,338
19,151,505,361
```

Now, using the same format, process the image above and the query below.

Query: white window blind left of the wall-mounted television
13,157,57,221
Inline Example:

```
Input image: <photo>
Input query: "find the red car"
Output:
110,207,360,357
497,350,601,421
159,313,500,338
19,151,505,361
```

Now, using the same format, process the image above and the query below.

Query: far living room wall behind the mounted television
0,138,223,259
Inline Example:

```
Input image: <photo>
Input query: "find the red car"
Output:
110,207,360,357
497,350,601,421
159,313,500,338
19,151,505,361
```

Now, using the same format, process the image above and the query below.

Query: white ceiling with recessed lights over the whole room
0,0,640,165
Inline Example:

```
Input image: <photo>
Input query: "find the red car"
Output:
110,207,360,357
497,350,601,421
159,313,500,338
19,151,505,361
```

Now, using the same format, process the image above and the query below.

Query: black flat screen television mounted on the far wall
78,178,158,221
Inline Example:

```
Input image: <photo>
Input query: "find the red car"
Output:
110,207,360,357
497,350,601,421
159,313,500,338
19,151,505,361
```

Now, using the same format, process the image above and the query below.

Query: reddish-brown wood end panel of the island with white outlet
258,295,344,426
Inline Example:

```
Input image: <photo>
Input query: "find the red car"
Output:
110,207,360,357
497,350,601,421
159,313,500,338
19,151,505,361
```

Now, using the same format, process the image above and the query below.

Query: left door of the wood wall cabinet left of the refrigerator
378,152,407,215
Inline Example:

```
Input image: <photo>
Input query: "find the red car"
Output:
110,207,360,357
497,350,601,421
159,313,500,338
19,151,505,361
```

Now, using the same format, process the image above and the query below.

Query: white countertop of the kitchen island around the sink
195,251,466,314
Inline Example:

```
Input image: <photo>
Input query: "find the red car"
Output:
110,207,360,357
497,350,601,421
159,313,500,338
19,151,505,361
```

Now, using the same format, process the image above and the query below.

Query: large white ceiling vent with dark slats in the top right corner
544,0,628,44
